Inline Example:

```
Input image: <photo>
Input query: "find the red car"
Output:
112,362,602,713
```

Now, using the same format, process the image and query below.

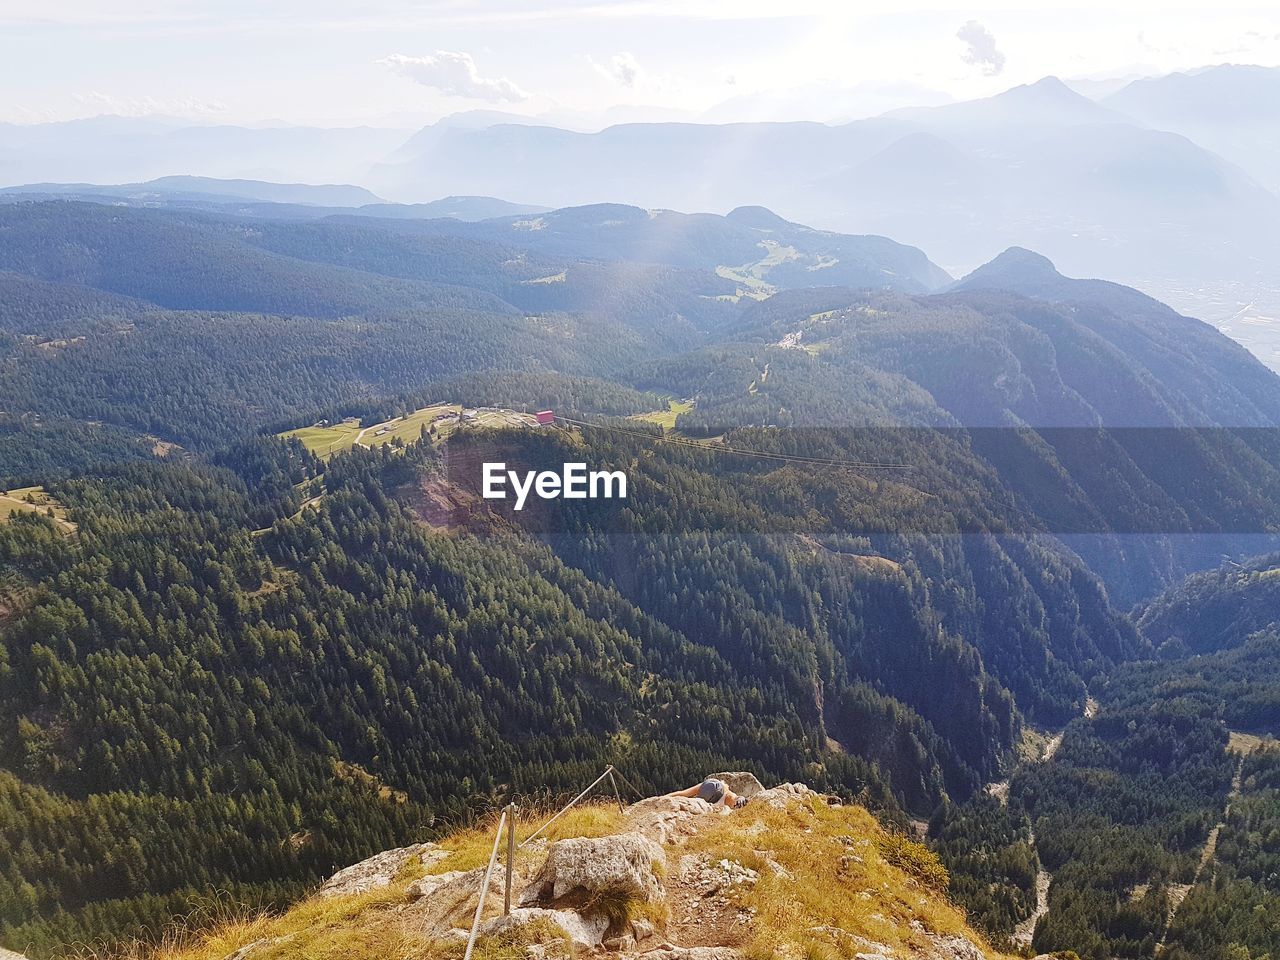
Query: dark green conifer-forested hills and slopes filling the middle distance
0,202,1280,960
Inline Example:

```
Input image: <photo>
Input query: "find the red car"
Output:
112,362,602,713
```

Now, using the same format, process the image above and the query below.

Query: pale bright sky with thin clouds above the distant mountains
0,0,1280,129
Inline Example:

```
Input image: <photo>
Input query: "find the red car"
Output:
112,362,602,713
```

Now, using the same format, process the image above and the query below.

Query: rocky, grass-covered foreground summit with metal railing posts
137,774,1049,960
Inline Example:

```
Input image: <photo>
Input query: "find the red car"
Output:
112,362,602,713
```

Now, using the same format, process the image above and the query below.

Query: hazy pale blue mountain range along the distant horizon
10,65,1280,366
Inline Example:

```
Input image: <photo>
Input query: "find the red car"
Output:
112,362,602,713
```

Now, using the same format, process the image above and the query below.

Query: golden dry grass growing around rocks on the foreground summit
95,797,998,960
